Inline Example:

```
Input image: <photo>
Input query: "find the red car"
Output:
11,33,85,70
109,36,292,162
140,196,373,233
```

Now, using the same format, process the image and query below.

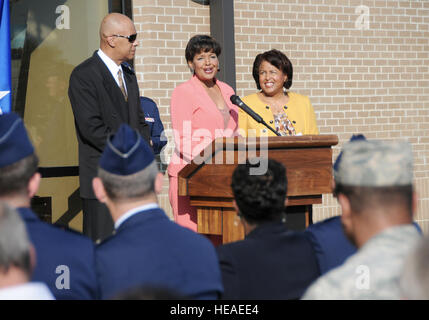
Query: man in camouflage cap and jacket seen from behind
303,140,420,299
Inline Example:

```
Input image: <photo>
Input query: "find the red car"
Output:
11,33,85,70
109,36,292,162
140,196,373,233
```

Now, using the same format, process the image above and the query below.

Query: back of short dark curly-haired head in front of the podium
231,159,287,224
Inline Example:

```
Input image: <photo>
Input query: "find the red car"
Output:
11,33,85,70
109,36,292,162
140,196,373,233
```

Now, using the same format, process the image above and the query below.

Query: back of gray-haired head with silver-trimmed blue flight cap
98,124,158,201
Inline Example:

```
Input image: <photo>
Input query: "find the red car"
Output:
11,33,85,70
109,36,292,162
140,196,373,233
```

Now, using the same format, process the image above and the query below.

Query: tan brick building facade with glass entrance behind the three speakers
10,0,429,231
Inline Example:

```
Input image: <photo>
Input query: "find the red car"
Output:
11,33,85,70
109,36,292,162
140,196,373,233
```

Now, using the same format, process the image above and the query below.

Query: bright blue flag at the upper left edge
0,0,12,114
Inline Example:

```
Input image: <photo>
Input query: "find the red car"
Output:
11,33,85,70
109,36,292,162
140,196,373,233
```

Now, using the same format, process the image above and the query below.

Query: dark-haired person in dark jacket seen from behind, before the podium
217,159,319,299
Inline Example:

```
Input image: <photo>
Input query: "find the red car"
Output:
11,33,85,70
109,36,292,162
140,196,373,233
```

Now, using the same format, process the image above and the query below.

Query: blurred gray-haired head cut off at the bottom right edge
400,237,429,300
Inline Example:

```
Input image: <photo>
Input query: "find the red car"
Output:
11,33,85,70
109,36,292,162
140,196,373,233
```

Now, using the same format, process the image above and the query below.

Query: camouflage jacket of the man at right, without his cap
303,224,421,300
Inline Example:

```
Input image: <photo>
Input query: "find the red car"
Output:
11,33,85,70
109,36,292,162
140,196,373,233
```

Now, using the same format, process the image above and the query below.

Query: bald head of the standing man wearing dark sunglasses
100,13,138,65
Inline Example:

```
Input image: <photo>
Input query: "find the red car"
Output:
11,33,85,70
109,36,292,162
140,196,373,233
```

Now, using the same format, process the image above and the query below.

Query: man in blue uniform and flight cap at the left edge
0,113,98,299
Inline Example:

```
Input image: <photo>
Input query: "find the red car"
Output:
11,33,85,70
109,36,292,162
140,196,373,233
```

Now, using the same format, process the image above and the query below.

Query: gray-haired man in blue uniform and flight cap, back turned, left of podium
93,124,223,299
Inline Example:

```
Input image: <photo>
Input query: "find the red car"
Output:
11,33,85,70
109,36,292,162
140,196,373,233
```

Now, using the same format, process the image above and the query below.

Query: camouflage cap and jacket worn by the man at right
302,140,421,300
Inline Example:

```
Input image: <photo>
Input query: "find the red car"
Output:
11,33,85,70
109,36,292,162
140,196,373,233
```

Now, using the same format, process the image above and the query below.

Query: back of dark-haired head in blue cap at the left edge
0,113,38,197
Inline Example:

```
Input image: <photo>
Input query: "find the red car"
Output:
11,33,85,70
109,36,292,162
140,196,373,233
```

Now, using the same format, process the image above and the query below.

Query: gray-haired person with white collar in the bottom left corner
0,202,54,300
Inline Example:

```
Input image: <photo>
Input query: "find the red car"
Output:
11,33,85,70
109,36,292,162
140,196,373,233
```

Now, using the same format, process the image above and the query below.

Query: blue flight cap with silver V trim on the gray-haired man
99,124,155,176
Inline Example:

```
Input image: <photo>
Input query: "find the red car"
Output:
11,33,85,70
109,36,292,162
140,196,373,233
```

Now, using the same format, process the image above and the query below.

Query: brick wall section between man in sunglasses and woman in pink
133,0,210,217
